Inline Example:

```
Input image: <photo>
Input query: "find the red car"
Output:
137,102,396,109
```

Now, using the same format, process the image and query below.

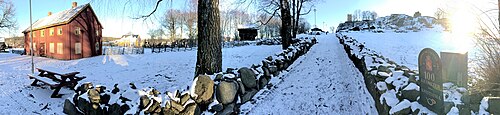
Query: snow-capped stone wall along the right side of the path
337,34,500,115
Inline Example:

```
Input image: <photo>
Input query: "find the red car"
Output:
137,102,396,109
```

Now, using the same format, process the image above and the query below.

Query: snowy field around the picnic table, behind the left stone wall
0,45,281,114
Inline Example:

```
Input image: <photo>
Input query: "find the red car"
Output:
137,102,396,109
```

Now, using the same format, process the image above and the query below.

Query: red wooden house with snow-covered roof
23,2,103,60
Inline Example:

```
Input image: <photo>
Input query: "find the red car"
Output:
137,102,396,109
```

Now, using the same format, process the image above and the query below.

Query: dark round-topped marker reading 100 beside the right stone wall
418,48,444,115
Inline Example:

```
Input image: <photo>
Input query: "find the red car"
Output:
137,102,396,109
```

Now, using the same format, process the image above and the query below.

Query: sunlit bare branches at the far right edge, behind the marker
472,0,500,96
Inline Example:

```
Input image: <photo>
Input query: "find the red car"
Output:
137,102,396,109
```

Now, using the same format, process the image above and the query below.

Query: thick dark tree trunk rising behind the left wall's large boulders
195,0,222,75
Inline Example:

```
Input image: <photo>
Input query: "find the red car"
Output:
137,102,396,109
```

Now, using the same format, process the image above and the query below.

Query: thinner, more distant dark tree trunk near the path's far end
280,0,292,49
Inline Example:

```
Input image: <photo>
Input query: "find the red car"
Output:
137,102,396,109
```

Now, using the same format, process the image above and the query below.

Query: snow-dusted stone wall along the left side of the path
63,38,316,115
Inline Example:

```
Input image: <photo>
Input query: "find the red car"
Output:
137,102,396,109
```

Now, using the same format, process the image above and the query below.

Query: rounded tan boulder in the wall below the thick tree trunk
191,74,214,105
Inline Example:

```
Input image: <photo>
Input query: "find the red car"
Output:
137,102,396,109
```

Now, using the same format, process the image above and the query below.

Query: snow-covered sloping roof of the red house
23,4,96,32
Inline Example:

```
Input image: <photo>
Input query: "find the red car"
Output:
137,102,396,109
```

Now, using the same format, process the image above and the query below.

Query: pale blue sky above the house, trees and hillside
3,0,490,37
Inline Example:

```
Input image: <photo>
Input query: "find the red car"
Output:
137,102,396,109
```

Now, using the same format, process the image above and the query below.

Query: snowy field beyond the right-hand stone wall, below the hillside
342,28,478,70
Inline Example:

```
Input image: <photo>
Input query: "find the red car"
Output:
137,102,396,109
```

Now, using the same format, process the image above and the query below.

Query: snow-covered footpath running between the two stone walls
242,34,377,115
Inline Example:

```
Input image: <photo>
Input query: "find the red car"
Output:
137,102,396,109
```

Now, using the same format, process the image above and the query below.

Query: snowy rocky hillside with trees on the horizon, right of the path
337,14,441,32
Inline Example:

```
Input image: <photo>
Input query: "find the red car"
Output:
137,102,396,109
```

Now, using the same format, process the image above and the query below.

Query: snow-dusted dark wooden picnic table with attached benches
28,68,85,98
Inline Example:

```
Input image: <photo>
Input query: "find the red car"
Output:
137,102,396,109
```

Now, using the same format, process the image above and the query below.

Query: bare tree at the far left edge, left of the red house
0,0,17,31
